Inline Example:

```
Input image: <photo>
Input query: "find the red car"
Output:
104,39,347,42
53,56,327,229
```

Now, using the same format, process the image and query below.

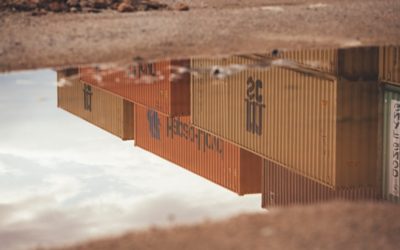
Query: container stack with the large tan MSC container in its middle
191,48,379,206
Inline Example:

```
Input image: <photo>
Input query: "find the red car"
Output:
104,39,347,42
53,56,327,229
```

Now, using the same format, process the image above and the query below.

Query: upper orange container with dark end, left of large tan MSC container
80,60,190,116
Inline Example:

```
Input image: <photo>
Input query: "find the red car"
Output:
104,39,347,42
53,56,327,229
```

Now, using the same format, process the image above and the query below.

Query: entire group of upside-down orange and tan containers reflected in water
58,46,400,208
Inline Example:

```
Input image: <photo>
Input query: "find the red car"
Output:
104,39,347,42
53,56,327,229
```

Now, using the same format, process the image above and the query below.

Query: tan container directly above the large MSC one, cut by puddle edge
278,47,379,80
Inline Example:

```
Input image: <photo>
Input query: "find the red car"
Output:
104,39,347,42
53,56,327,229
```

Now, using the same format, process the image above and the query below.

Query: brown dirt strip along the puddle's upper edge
0,0,400,72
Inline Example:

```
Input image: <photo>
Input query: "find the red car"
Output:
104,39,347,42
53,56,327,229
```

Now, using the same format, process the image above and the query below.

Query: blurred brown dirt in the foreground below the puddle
43,202,400,250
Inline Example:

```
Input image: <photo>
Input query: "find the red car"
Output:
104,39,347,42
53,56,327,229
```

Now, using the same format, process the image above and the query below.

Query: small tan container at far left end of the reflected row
57,72,134,140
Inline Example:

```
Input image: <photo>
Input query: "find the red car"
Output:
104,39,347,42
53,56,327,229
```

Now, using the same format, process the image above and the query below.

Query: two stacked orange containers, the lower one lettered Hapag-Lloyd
57,60,262,195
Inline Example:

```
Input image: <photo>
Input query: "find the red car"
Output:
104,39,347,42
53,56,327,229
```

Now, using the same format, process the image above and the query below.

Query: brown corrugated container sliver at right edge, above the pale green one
379,46,400,85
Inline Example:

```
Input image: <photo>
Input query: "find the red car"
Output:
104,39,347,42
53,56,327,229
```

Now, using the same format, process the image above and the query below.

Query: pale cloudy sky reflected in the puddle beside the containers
0,70,262,250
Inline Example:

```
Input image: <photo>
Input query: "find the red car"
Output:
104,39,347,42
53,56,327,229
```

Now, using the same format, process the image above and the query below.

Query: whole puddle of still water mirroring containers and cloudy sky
0,45,400,249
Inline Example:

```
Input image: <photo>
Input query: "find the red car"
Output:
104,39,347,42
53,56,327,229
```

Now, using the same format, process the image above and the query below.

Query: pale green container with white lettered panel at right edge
382,84,400,202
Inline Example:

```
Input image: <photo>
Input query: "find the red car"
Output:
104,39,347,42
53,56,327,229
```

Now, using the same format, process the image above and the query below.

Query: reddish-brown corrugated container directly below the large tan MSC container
262,160,380,208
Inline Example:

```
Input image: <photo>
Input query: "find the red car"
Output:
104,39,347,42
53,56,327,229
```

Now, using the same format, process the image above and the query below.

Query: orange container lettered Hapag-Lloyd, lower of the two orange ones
135,106,262,195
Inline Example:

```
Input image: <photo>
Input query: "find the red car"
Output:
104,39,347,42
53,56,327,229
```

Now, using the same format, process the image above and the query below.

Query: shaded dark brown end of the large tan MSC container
335,80,380,186
